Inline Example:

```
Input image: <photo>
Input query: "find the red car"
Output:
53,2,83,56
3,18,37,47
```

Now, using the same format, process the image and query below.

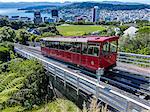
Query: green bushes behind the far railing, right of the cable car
120,26,150,55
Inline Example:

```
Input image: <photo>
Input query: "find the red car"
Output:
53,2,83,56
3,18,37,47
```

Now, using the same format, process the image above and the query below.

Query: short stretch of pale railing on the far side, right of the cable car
117,52,150,67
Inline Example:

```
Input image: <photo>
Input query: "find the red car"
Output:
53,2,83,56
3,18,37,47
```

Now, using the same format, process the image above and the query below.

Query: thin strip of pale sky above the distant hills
0,0,150,4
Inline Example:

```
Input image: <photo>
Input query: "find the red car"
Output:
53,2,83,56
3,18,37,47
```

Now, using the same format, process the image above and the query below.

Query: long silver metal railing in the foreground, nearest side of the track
15,46,150,112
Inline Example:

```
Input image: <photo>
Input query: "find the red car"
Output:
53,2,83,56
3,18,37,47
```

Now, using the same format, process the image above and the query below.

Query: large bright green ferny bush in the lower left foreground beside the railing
0,59,48,110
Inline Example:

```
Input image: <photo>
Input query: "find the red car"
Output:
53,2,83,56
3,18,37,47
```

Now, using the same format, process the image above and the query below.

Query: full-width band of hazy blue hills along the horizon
0,1,150,10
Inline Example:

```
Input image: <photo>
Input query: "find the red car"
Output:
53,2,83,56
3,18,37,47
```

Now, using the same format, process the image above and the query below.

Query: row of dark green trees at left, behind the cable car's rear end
0,26,59,45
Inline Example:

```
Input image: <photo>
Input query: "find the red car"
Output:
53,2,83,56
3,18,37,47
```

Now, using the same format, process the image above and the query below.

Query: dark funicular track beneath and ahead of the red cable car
21,47,150,101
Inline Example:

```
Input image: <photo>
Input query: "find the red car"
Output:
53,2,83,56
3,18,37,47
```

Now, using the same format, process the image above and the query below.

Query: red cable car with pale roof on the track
41,36,119,71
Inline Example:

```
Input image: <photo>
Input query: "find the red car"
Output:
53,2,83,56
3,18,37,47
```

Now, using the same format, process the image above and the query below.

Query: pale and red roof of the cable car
41,36,119,43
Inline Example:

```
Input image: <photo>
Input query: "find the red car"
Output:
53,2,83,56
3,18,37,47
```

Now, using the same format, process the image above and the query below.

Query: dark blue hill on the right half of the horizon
62,2,150,10
